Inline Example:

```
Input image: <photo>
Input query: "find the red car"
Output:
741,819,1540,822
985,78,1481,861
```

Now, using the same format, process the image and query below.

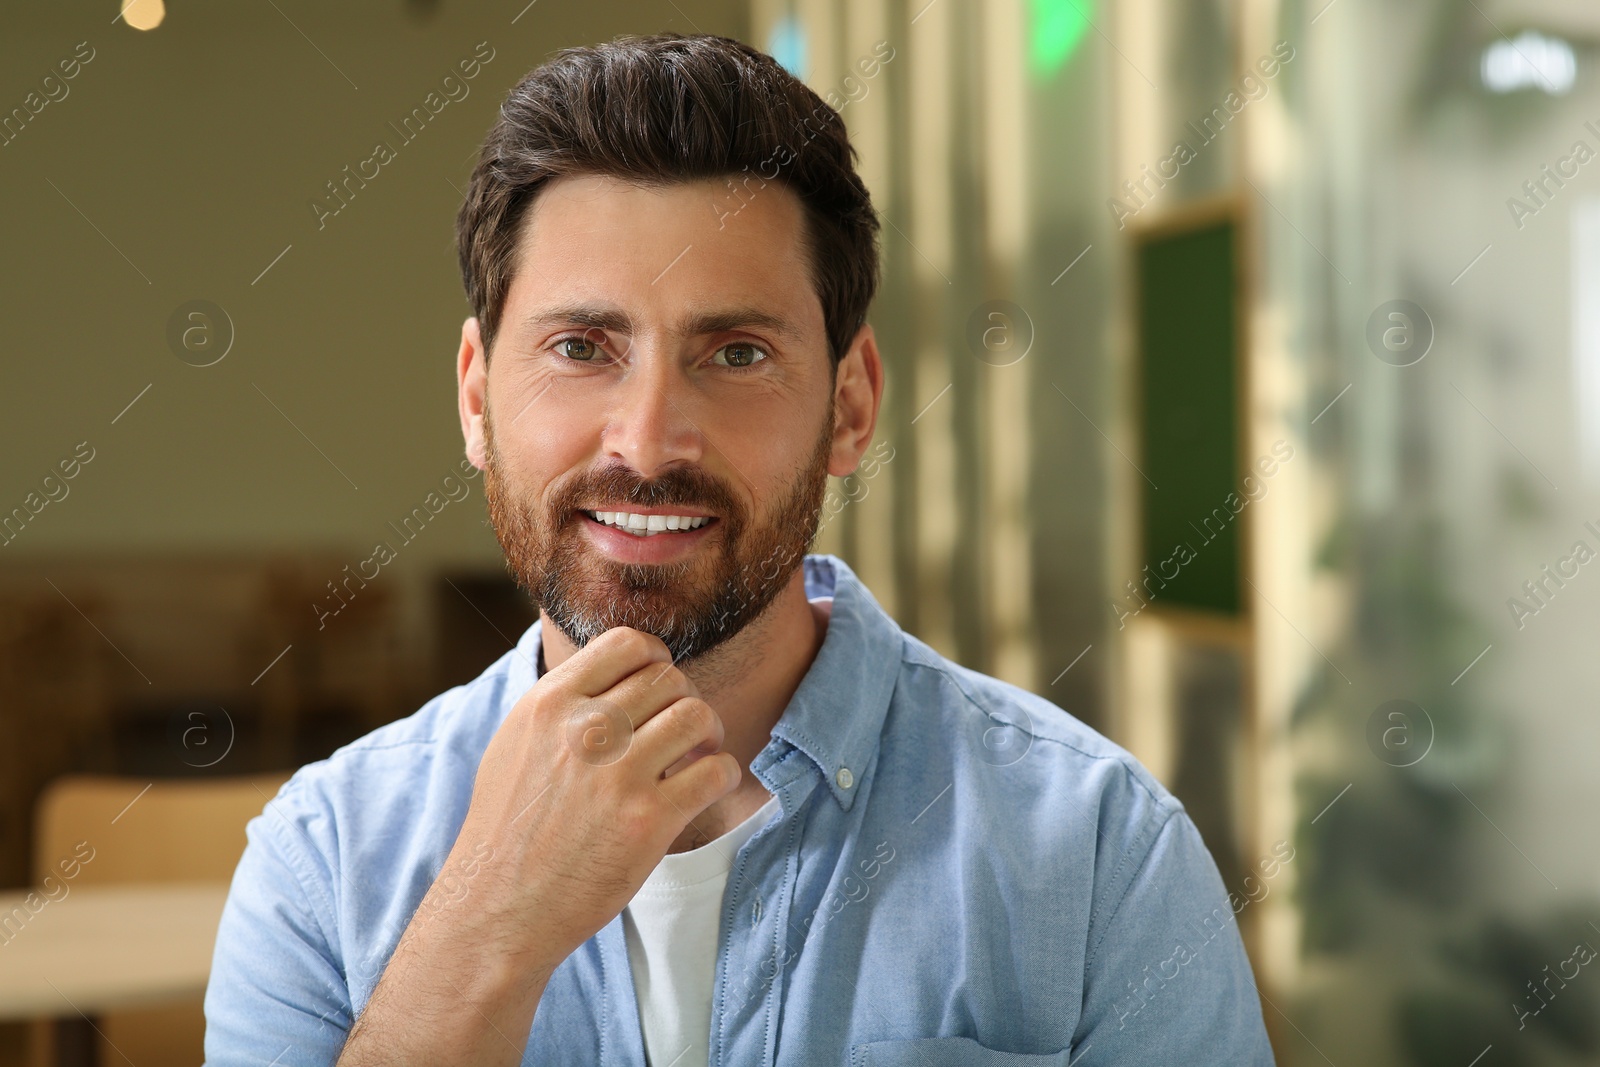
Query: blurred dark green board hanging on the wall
1136,219,1246,616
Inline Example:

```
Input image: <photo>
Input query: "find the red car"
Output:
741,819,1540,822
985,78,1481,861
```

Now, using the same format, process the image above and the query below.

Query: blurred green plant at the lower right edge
1291,495,1600,1067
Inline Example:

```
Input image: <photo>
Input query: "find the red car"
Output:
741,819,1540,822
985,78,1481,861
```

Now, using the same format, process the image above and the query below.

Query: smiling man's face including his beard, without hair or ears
467,176,854,661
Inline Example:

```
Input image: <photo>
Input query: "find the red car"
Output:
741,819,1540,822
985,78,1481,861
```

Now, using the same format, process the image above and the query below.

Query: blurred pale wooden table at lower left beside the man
0,883,227,1065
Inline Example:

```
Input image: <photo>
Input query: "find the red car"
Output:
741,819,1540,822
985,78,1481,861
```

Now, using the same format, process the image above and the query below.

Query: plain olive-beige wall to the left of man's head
0,0,749,573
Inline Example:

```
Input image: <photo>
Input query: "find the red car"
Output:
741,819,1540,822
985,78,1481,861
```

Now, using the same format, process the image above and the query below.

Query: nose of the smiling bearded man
600,339,706,478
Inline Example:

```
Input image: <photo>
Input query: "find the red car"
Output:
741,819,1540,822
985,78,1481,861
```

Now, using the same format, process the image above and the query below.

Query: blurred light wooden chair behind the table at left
30,773,288,1067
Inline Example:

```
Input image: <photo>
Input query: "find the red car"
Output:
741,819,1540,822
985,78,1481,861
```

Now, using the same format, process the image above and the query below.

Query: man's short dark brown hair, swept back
456,34,878,368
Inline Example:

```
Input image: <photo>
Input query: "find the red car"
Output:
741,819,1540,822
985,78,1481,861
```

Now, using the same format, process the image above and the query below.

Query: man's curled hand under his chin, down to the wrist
446,627,741,969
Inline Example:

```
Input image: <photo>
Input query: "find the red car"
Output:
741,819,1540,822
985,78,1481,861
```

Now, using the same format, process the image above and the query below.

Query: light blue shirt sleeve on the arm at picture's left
205,795,352,1067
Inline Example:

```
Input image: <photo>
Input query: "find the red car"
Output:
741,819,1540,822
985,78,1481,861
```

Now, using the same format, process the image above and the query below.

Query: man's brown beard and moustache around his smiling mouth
483,405,834,664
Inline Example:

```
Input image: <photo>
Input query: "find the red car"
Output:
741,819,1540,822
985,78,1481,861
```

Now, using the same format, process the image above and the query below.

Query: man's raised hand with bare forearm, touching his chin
339,627,741,1067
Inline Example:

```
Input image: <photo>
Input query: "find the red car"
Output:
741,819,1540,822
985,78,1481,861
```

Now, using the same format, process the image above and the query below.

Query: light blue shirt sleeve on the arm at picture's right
1072,809,1274,1067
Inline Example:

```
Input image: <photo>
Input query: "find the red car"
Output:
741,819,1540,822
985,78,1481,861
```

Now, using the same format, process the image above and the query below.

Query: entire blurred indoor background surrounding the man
0,0,1600,1067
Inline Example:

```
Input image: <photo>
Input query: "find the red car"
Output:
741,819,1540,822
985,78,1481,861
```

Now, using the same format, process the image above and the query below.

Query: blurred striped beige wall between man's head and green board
752,0,1136,725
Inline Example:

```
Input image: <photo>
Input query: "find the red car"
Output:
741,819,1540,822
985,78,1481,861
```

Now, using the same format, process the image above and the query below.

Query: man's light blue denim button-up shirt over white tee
205,555,1272,1067
